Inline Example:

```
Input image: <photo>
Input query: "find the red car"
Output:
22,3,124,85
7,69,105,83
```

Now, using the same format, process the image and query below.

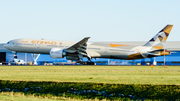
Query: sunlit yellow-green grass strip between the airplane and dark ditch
0,66,180,85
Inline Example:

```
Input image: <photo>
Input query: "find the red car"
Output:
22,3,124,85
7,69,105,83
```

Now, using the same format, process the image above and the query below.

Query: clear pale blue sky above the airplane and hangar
0,0,180,43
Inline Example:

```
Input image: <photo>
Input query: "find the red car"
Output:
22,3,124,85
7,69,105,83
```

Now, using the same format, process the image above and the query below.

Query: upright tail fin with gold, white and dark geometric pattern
144,25,173,49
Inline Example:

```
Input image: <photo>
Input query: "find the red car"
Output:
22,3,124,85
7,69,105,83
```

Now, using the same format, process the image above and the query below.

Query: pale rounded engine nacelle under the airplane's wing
49,48,66,58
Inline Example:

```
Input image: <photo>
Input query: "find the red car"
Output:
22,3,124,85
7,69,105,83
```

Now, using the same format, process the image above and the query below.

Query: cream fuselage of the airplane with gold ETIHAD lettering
4,39,156,59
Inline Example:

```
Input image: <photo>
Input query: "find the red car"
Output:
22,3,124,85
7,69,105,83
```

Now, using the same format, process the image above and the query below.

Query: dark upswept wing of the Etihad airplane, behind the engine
66,37,90,54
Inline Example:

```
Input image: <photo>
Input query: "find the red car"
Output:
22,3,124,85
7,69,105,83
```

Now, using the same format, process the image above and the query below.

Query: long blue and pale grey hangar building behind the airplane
0,41,180,65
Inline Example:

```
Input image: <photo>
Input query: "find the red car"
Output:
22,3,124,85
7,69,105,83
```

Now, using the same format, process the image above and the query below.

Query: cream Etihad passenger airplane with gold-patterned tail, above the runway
4,25,173,65
